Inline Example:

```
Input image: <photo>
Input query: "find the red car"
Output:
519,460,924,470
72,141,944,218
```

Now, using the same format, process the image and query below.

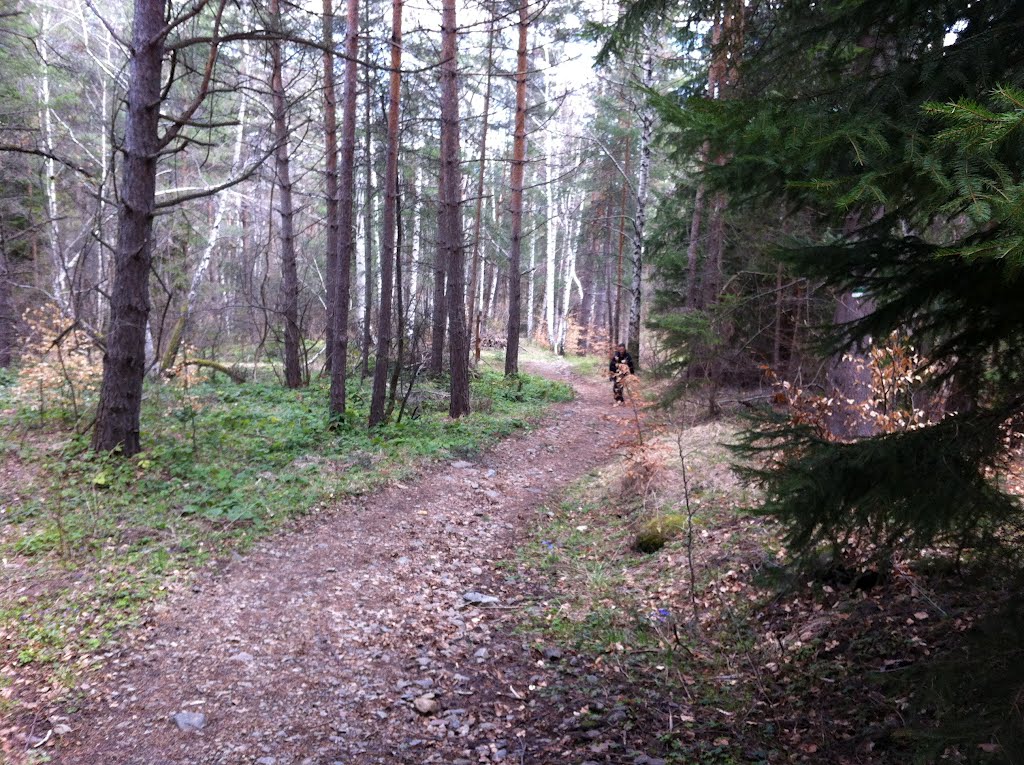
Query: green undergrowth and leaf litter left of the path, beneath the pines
0,369,572,700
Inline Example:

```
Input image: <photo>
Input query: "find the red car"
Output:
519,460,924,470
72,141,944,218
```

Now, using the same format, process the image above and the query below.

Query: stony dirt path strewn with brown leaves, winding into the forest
58,360,630,765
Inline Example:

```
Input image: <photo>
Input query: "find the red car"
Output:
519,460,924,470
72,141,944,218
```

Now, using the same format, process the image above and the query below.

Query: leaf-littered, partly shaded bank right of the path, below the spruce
516,423,1024,765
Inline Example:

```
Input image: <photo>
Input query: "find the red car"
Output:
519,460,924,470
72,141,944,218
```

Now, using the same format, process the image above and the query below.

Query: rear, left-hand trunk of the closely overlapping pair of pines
324,0,340,373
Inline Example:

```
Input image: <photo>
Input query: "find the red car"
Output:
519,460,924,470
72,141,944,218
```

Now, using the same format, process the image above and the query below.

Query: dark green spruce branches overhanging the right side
638,0,1024,552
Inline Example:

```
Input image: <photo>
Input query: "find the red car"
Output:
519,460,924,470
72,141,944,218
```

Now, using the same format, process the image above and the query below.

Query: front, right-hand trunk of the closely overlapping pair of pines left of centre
330,0,359,421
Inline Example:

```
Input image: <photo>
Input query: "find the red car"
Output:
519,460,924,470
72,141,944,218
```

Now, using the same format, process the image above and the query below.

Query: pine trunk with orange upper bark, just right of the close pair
370,0,401,427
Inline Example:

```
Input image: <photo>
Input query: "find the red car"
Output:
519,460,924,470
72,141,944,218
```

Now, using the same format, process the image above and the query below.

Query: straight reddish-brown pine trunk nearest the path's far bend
505,0,534,376
